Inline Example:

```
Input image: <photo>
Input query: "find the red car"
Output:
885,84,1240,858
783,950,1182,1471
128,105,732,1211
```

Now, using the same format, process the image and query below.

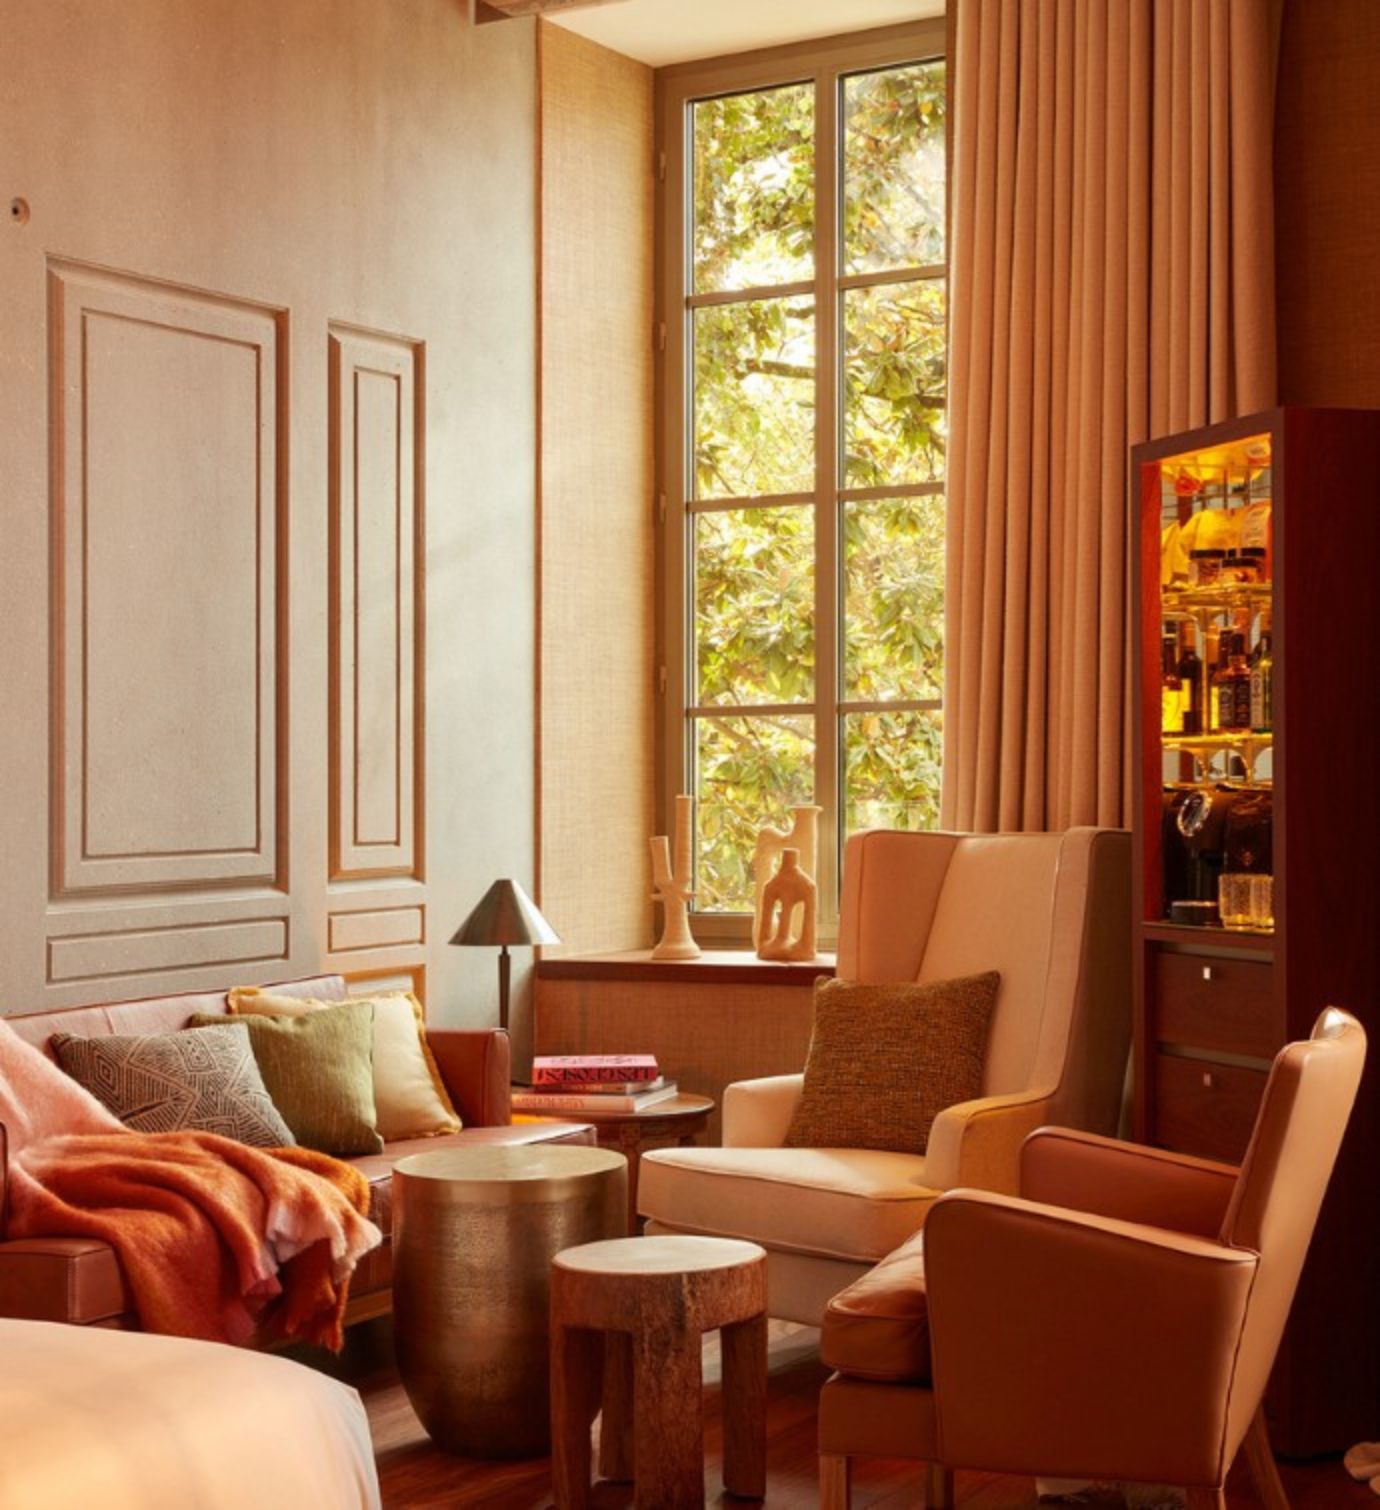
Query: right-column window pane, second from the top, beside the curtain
844,278,945,488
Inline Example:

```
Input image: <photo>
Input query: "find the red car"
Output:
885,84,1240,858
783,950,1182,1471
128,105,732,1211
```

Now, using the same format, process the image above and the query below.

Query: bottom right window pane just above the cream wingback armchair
842,710,944,834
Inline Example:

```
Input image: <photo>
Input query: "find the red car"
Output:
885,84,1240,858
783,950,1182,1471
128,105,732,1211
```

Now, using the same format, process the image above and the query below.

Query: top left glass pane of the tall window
692,85,815,293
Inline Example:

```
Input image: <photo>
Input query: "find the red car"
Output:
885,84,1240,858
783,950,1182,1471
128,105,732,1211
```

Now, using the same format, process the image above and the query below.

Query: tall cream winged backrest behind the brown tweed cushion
838,827,1131,1133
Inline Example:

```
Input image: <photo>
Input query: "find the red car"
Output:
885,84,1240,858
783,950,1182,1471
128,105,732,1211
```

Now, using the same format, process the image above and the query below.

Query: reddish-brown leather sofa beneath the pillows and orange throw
0,975,595,1330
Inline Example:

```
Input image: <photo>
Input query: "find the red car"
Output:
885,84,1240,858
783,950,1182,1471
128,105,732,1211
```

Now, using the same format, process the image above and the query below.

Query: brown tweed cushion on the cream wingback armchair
785,969,1001,1154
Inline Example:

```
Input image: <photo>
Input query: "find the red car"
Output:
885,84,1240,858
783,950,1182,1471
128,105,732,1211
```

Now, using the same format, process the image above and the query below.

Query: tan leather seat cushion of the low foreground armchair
820,1232,930,1385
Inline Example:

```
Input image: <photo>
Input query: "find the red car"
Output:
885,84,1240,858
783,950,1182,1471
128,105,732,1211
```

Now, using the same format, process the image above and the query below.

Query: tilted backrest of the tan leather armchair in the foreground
1221,1007,1366,1450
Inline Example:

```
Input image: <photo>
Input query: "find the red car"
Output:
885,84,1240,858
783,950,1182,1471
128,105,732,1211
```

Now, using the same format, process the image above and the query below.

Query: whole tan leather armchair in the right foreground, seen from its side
820,1010,1365,1510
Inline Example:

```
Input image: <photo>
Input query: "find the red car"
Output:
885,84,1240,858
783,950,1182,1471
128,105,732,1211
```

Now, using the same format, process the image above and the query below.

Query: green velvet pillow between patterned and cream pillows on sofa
189,1001,384,1155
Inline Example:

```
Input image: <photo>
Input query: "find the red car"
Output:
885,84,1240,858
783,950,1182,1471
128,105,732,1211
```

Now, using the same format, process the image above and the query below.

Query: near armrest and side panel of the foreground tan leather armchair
926,1190,1259,1486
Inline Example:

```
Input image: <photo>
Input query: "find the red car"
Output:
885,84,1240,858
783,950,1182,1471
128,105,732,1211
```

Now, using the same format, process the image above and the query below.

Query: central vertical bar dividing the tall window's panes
814,68,842,921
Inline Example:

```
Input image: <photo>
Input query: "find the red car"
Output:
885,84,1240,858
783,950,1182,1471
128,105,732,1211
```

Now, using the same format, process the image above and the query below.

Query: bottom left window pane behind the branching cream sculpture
695,716,814,912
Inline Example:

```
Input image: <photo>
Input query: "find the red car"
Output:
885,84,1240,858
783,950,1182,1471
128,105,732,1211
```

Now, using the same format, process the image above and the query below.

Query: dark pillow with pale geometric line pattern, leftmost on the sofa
51,1025,296,1148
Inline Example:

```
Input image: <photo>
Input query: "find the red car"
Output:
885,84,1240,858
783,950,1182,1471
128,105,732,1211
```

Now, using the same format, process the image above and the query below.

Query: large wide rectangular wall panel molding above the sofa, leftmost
48,261,287,893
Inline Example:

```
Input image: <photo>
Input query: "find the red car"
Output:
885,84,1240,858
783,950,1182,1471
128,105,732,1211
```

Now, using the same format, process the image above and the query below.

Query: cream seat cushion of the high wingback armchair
637,1148,939,1264
